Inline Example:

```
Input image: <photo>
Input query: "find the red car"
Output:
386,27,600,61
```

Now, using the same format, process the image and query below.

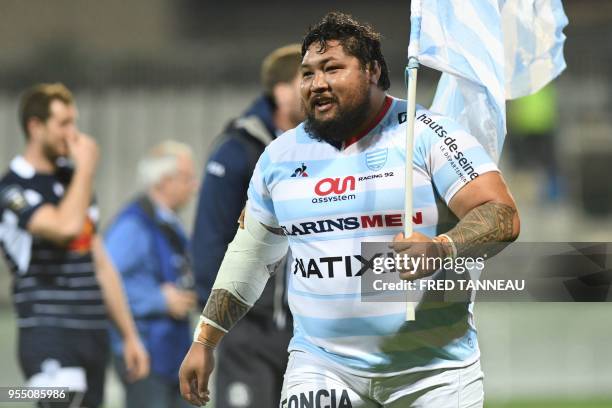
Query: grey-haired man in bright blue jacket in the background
106,141,197,408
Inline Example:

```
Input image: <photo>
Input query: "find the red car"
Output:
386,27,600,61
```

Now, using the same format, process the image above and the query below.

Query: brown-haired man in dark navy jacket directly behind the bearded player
193,44,306,408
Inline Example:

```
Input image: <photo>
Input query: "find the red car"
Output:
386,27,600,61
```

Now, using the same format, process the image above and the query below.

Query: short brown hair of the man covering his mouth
19,83,74,139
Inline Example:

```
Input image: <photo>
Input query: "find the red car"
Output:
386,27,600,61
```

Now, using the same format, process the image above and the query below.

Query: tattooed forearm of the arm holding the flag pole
446,203,516,255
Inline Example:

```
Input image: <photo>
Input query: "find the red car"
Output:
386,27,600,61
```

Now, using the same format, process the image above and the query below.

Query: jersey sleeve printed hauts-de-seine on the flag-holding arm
415,112,499,204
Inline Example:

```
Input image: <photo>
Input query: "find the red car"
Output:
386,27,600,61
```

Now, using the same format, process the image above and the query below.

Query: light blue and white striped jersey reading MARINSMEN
247,97,497,376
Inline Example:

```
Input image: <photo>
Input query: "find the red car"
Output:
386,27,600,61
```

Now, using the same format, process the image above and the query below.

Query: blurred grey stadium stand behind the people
0,0,612,407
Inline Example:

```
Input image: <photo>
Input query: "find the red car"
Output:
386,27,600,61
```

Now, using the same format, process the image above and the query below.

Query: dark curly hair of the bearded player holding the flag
302,11,391,91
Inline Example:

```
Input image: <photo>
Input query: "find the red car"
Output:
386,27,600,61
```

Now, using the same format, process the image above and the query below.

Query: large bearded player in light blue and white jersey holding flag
179,2,568,408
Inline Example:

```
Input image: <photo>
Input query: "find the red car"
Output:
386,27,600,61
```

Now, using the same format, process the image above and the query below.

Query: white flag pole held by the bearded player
404,56,419,321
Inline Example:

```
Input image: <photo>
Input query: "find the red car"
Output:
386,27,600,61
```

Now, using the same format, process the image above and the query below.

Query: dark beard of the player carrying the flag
304,84,372,144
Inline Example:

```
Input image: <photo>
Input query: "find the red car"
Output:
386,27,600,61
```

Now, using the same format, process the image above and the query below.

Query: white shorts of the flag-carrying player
280,351,484,408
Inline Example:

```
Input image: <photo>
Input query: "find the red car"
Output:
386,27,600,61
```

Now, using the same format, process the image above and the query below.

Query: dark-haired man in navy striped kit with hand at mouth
0,84,149,407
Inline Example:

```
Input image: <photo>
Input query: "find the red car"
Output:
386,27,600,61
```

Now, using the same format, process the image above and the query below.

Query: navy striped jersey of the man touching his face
0,156,108,330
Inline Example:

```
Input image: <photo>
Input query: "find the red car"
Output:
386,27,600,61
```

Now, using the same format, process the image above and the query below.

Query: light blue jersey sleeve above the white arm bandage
247,150,279,227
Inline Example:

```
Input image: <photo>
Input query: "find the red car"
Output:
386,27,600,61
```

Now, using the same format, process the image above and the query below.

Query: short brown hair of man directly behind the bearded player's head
261,44,302,98
